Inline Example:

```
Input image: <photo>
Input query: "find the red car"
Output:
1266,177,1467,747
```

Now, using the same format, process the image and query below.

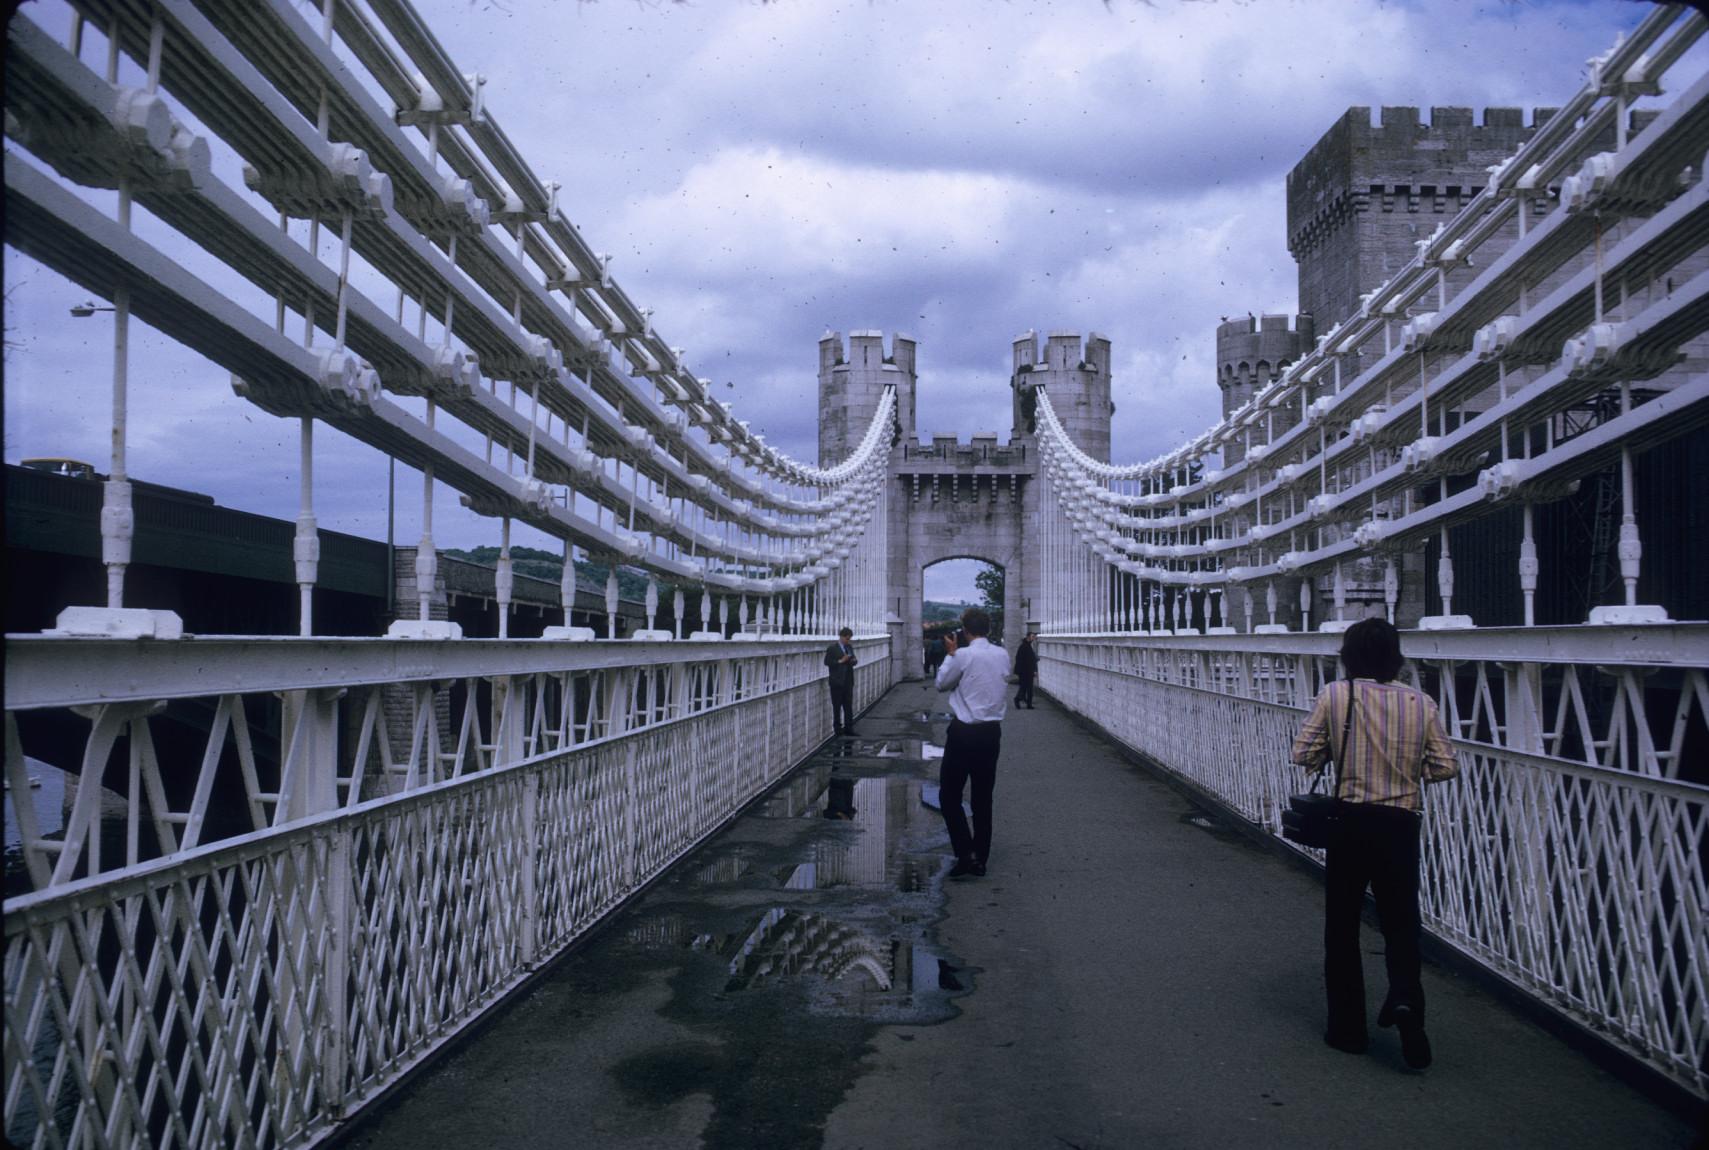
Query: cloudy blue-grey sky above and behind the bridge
5,0,1651,598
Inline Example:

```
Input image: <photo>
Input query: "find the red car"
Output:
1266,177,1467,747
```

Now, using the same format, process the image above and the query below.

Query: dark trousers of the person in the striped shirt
1323,803,1424,1039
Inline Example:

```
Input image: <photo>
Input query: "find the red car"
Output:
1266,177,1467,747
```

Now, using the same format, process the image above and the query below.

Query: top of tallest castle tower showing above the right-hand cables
1287,108,1555,332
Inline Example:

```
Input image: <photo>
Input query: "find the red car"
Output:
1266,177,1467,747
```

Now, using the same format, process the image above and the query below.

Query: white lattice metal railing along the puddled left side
5,637,890,1147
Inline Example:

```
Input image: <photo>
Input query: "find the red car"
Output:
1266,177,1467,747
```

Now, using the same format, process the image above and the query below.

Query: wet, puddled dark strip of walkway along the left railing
362,704,974,1147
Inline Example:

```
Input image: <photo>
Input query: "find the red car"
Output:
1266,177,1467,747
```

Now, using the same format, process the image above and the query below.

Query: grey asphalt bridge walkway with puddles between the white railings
336,684,1692,1150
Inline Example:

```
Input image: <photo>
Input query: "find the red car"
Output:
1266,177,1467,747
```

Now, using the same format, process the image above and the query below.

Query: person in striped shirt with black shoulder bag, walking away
1294,619,1459,1070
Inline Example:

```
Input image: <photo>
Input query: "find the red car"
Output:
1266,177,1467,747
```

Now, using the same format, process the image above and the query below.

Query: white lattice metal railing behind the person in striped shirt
1039,624,1709,1095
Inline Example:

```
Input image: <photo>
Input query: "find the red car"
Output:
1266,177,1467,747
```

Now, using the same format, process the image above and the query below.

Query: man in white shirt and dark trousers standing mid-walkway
938,607,1008,878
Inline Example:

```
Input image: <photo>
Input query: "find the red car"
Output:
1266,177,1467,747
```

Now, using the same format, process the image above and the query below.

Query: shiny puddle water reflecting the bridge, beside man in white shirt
611,721,971,1022
